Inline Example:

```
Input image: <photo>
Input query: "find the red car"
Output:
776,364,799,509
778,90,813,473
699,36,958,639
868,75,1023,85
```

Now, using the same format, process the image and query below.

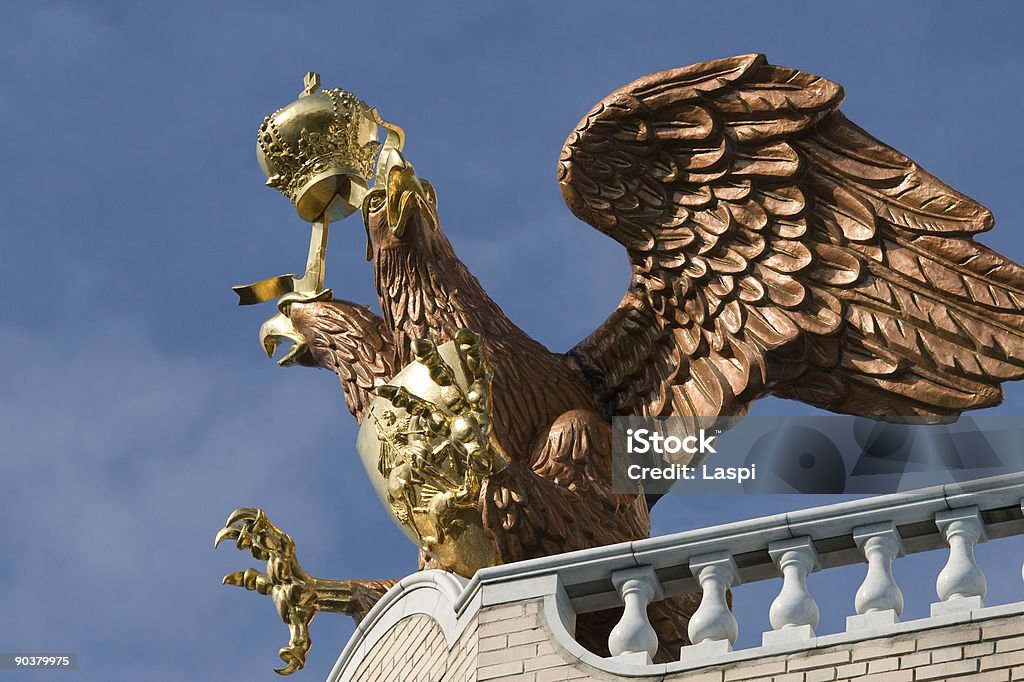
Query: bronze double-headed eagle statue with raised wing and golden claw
218,54,1024,672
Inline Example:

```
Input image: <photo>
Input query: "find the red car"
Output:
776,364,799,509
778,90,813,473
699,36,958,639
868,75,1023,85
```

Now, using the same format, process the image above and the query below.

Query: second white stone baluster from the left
683,552,740,655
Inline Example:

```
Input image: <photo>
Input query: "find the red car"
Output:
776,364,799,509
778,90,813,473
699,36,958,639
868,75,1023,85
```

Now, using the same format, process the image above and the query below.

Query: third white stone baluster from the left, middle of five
762,537,820,646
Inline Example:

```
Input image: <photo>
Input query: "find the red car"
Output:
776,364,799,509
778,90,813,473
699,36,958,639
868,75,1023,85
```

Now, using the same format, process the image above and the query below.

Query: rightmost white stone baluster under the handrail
932,507,988,615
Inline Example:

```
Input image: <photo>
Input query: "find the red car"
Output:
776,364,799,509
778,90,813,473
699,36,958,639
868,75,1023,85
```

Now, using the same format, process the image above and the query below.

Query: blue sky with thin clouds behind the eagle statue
6,1,1024,681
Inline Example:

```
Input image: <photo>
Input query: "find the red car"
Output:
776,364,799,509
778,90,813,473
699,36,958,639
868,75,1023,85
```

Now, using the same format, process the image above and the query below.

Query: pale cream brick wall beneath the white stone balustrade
342,600,1024,682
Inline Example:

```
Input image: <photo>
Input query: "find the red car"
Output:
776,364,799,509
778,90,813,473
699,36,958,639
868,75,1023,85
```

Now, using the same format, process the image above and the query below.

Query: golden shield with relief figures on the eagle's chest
356,330,508,576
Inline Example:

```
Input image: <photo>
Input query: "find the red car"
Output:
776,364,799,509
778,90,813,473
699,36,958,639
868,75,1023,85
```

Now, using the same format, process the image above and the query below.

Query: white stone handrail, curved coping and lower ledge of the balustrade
328,473,1024,682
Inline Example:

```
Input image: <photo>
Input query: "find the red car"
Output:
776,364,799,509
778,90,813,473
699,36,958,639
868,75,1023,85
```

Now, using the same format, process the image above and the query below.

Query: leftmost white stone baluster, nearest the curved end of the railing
608,566,664,664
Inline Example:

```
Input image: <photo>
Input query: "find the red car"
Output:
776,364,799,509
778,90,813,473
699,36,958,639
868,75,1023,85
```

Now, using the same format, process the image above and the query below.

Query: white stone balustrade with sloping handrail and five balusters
464,473,1024,664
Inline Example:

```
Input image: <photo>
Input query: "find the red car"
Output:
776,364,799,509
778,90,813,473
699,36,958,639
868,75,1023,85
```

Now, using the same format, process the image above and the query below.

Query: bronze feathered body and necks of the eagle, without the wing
290,204,650,562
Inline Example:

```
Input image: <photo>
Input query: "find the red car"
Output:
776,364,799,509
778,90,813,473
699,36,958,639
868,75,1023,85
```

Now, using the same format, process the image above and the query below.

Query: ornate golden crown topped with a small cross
256,79,381,220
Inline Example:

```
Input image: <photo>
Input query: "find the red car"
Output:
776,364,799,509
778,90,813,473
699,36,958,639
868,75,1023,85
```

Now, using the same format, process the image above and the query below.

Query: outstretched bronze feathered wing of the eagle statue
559,54,1024,417
